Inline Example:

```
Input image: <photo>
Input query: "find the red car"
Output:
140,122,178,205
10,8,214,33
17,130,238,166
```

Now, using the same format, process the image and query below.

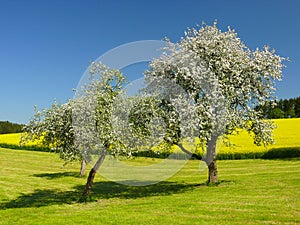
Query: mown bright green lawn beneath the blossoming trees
0,149,300,225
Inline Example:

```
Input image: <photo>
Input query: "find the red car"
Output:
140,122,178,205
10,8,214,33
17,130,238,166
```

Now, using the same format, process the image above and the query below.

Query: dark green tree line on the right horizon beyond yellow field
256,96,300,119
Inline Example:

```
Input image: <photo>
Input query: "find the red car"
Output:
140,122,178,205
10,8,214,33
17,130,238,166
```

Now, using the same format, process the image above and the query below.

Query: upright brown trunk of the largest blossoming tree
205,136,219,184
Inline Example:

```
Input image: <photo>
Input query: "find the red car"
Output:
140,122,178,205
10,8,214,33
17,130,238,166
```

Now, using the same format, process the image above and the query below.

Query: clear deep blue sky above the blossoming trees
0,0,300,123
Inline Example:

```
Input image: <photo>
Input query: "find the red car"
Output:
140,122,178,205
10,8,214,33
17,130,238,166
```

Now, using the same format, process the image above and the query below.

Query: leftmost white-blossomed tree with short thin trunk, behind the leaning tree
21,100,86,176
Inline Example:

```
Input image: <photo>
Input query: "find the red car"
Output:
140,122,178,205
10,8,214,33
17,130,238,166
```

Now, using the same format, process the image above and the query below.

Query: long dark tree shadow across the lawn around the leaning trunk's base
0,181,199,209
